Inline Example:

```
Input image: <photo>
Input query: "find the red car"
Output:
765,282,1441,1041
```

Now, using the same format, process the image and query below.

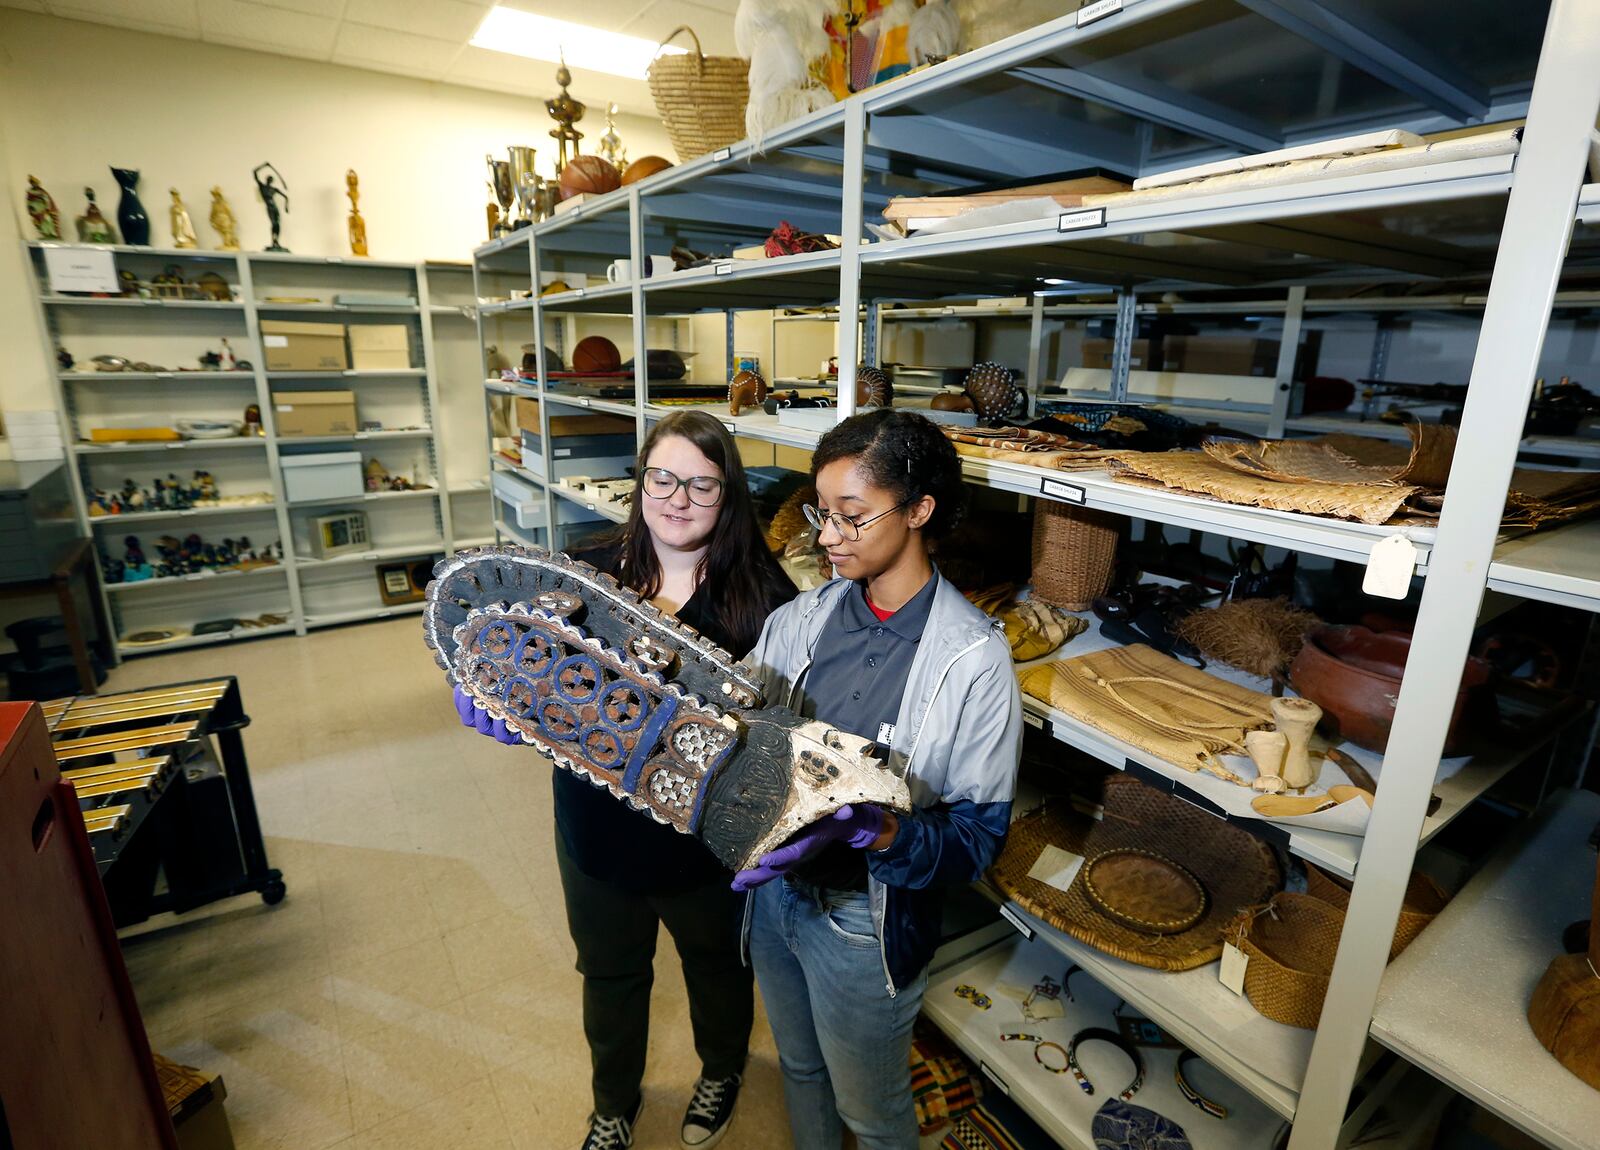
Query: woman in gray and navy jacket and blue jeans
734,409,1022,1150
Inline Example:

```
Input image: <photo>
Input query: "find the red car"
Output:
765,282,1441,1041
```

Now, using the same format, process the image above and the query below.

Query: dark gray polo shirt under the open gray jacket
794,573,939,891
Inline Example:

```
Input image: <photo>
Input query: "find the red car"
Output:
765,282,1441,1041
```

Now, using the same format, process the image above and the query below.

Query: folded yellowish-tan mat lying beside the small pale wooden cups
1021,643,1272,782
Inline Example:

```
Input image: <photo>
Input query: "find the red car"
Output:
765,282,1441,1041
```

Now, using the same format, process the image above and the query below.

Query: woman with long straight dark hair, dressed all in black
458,411,795,1150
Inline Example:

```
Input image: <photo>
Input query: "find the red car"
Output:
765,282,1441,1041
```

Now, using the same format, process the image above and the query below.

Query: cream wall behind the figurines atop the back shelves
0,8,672,447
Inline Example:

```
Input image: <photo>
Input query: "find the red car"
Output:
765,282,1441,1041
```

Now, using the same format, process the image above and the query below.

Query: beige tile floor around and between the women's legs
106,617,790,1150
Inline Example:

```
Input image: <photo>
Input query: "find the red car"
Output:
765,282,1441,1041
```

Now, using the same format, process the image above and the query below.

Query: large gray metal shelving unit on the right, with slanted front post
457,0,1600,1150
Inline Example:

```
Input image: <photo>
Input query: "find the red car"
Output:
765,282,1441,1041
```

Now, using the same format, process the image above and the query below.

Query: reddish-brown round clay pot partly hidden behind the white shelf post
1290,627,1490,755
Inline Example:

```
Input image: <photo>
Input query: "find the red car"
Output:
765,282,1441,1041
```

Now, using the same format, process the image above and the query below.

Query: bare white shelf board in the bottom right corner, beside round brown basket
1373,792,1600,1150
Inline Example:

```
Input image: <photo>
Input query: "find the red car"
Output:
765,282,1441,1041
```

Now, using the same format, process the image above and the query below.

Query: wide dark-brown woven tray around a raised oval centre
989,774,1283,971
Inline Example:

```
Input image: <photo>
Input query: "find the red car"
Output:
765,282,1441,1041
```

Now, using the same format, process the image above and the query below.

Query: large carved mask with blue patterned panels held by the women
422,547,910,870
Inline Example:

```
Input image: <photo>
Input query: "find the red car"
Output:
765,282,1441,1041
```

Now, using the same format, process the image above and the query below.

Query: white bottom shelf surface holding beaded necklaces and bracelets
923,936,1286,1150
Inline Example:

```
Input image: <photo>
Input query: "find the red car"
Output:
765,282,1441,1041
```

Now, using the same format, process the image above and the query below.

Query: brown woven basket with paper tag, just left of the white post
1227,891,1344,1030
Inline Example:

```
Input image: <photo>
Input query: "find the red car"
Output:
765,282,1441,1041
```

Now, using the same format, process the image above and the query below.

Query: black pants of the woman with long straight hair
555,830,755,1116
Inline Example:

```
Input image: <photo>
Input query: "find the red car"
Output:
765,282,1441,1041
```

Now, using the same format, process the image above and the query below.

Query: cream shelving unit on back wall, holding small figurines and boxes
27,243,482,656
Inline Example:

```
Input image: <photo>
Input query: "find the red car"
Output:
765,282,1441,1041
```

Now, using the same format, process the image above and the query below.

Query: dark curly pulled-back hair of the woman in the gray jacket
811,408,966,539
